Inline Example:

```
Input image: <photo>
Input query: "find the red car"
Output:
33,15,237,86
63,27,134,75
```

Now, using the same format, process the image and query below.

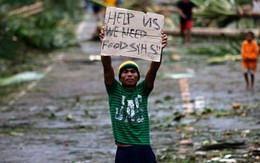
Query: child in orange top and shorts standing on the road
241,31,259,90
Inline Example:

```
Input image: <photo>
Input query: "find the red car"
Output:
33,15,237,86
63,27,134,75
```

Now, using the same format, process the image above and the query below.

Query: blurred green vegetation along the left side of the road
0,0,84,102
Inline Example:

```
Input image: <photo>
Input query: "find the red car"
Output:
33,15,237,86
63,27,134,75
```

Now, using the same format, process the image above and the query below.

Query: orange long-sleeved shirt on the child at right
241,40,258,59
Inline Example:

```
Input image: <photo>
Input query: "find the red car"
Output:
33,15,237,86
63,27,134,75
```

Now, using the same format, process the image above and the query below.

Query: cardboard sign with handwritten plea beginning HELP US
101,7,164,62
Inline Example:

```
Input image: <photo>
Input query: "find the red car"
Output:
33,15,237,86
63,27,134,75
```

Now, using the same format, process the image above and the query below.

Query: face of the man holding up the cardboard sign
120,68,139,88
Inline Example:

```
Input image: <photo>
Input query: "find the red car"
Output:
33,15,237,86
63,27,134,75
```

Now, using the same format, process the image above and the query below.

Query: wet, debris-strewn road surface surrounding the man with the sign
0,15,260,163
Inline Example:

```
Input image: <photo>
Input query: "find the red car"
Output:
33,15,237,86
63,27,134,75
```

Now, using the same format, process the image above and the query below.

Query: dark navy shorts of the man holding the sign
115,145,156,163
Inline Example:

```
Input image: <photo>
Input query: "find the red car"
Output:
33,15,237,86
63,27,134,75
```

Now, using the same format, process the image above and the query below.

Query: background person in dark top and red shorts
177,0,196,44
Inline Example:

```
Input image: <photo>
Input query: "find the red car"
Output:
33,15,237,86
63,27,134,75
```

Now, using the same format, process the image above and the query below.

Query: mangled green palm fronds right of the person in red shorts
194,0,260,27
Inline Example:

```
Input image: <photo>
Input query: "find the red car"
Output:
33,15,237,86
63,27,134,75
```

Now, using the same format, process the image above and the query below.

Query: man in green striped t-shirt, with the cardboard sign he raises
100,8,167,163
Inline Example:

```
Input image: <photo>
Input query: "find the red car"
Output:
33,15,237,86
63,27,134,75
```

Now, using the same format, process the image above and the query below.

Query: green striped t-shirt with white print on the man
106,79,152,145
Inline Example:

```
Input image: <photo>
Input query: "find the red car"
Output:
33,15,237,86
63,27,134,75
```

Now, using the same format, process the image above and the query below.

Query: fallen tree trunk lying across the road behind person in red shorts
163,27,260,37
